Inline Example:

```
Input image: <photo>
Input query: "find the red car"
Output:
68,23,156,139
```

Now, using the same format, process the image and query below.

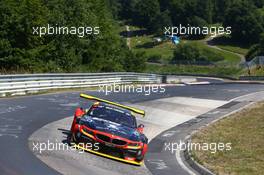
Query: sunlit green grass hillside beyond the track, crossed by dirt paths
126,26,242,77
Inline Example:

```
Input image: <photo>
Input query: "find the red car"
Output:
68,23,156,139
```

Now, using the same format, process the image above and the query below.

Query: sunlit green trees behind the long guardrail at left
0,0,144,72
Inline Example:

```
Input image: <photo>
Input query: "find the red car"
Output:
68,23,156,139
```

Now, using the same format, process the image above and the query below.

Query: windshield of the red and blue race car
88,106,137,128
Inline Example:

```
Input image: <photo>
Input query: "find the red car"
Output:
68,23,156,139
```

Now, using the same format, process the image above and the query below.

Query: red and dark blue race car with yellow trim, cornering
70,94,148,165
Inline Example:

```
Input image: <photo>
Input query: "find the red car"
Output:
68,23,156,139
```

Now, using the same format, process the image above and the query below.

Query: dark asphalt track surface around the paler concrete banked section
0,82,264,175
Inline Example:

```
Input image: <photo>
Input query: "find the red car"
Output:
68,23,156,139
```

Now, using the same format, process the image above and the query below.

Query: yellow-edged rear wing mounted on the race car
80,94,145,117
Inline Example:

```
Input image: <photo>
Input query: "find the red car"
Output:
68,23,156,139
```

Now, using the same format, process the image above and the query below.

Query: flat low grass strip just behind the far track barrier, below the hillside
145,64,242,78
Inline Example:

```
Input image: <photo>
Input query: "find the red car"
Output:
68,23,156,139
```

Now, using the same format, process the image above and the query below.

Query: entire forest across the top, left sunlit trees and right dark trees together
0,0,264,73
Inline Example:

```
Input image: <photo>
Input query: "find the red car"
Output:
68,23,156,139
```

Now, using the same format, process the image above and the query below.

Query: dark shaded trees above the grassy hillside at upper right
117,0,264,43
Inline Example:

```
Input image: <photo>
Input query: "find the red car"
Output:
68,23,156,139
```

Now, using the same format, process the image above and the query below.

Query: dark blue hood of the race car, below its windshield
83,118,140,141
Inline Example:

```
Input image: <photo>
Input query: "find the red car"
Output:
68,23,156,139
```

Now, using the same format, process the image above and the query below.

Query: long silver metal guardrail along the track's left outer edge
0,72,162,96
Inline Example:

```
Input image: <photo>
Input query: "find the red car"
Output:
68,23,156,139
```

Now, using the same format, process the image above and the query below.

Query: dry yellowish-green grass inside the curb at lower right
192,102,264,175
